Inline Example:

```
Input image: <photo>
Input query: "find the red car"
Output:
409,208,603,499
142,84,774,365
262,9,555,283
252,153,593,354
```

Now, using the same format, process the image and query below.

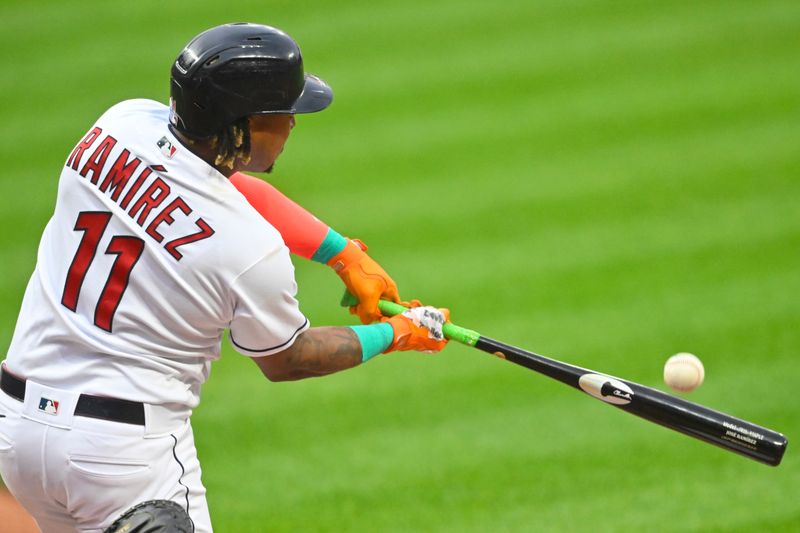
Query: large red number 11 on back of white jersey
61,211,144,332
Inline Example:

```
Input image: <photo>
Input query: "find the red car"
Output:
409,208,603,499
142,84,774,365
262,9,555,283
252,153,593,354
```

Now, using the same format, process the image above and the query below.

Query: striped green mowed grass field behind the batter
0,0,800,532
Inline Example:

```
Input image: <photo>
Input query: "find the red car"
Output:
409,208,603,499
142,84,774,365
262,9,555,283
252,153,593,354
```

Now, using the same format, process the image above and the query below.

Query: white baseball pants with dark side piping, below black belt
0,381,211,533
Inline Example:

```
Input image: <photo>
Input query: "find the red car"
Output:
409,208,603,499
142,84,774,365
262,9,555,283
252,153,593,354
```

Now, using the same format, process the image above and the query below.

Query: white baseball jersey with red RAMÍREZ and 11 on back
5,100,309,413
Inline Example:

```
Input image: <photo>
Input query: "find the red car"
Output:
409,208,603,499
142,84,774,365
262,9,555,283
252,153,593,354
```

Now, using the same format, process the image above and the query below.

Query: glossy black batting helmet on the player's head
170,23,333,138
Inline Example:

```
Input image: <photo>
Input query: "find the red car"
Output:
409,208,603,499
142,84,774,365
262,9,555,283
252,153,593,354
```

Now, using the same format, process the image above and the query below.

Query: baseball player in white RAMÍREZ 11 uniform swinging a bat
0,24,447,533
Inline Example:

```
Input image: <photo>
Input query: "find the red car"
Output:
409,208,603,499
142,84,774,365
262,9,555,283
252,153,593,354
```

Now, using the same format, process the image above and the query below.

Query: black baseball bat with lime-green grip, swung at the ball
379,300,788,466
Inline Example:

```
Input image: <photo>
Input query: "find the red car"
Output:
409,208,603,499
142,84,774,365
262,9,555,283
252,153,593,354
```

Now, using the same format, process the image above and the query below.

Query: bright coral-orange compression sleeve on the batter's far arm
230,172,329,259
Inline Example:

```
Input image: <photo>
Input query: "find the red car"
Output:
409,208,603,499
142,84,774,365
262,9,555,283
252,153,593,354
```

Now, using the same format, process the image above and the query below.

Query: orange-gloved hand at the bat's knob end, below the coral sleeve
328,240,400,324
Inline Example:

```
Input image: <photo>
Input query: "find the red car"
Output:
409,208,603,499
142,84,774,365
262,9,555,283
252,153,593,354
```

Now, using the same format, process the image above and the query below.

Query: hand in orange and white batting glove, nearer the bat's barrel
384,306,450,353
